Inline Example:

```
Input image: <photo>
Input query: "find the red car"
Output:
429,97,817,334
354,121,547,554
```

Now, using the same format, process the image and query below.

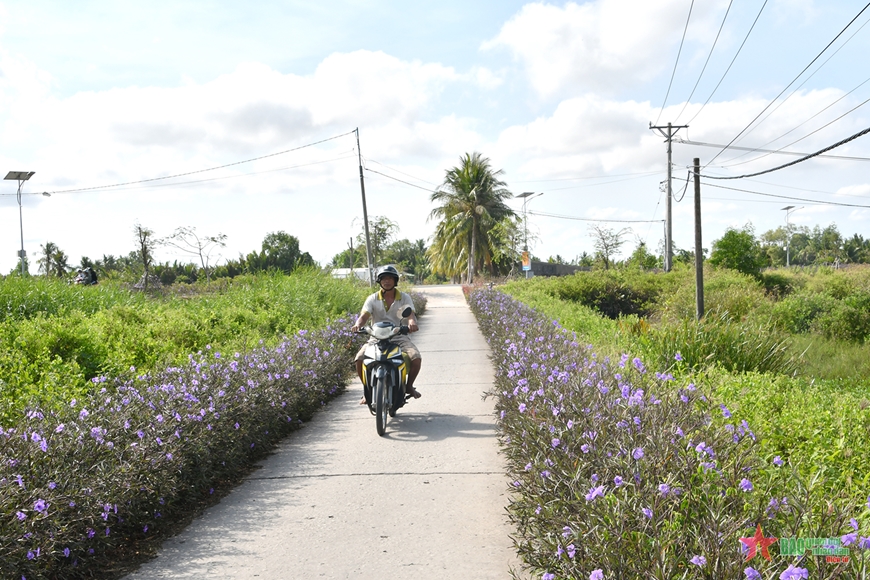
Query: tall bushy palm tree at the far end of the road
429,152,516,284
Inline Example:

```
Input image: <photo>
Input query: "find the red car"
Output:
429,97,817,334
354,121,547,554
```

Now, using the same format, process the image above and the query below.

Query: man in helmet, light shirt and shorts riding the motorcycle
350,266,422,405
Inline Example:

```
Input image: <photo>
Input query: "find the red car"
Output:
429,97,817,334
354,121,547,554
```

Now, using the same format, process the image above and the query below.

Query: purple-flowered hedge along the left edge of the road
0,317,354,580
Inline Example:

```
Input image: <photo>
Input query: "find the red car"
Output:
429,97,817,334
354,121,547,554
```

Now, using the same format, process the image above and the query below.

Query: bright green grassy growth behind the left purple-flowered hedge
0,269,370,424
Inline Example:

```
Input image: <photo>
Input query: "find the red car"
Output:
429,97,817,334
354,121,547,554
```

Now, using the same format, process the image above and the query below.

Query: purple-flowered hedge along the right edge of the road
470,290,870,580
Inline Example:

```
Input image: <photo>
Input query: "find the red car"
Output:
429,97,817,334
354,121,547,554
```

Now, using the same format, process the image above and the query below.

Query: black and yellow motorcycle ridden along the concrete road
359,307,412,435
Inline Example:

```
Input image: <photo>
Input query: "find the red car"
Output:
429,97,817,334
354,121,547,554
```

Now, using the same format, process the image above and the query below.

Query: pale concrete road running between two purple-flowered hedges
122,286,516,580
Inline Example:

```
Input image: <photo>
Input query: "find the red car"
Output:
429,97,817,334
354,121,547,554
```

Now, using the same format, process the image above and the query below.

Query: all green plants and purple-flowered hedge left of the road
0,268,426,580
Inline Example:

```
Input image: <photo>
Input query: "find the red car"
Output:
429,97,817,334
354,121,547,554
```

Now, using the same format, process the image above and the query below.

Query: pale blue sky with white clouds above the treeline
0,0,870,274
